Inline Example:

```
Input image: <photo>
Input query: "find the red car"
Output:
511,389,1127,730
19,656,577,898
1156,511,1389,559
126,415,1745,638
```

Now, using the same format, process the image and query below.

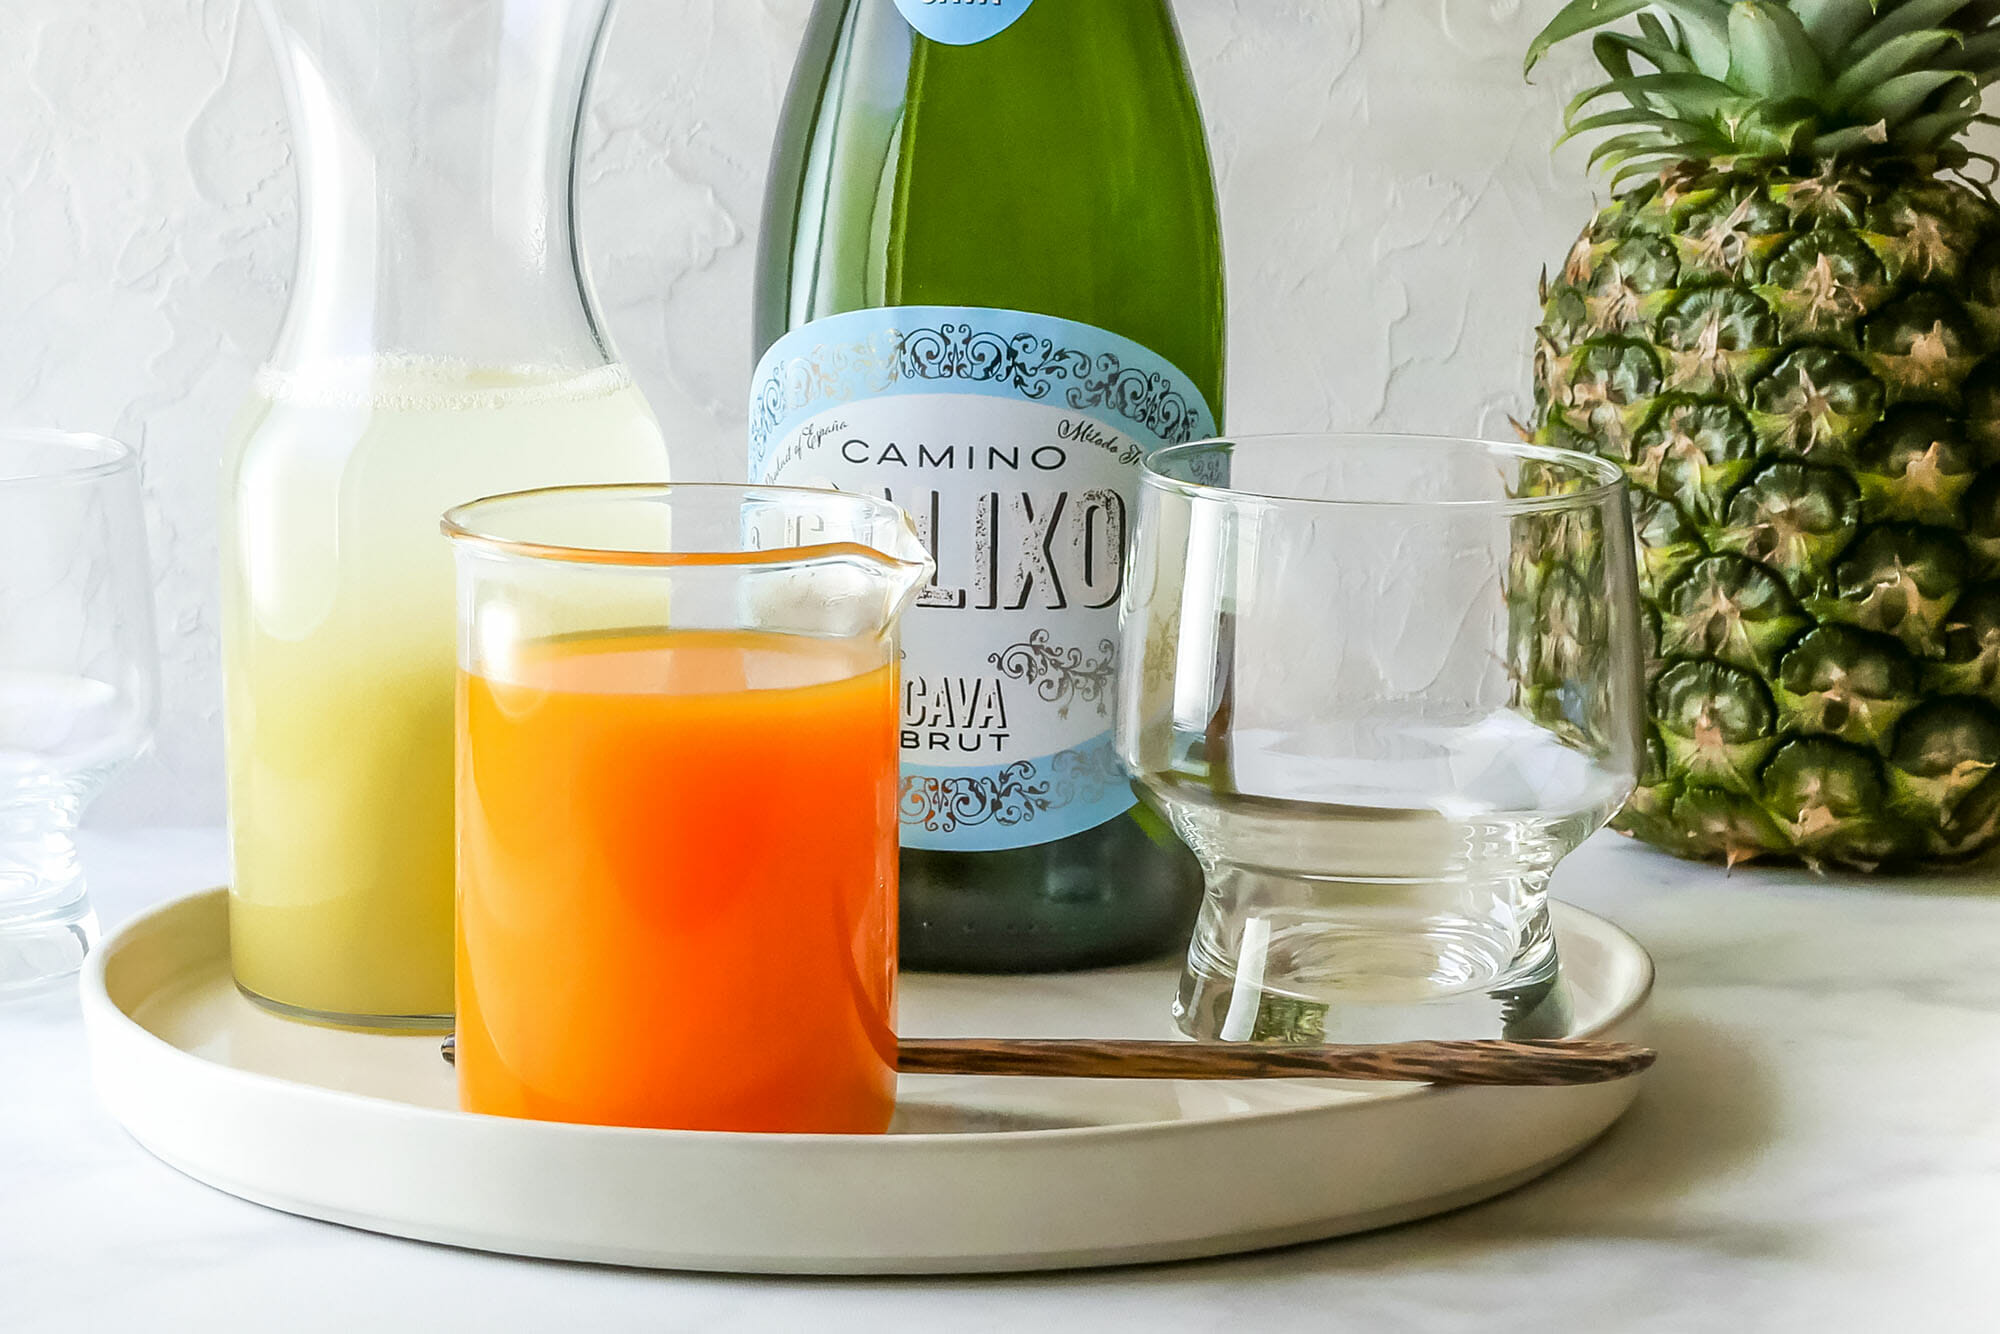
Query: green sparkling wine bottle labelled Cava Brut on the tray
750,0,1224,972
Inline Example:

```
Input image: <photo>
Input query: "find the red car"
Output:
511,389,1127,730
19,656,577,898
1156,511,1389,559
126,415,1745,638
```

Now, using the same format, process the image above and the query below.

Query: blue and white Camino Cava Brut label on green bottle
750,306,1216,852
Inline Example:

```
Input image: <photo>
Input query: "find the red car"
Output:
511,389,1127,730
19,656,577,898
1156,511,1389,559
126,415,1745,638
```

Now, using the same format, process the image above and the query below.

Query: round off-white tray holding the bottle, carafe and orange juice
82,890,1652,1274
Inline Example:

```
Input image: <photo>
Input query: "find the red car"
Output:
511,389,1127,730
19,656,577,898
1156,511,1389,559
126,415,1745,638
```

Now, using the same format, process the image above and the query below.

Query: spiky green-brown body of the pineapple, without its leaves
1534,164,2000,868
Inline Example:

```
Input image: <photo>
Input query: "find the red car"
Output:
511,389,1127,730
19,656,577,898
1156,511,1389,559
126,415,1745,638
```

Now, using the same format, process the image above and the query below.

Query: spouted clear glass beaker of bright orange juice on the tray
446,486,932,1134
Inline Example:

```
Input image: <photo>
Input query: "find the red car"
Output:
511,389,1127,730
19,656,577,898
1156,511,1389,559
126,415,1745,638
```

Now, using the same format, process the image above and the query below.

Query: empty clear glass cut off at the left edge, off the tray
0,430,156,996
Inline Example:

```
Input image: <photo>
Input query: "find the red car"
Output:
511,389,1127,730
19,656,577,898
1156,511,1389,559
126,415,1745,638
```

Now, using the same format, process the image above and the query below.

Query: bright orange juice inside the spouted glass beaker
458,630,898,1132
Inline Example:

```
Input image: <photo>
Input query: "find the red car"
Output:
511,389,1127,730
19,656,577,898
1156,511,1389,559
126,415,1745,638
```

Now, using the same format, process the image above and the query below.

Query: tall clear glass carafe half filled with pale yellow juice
222,0,666,1030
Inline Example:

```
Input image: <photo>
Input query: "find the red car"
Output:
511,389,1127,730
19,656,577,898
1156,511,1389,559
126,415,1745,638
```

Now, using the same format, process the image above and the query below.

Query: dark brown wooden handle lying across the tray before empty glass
896,1038,1654,1088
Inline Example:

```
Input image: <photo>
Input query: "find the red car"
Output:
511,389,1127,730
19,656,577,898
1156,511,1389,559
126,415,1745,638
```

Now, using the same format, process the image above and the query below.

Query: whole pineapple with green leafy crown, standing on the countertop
1528,0,2000,868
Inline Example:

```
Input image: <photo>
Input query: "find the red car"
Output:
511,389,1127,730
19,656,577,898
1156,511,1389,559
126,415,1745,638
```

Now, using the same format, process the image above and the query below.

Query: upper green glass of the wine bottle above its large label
754,0,1224,410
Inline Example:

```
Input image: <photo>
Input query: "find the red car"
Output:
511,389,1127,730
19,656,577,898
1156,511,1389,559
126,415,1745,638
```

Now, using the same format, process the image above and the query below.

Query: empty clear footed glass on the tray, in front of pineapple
1118,436,1642,1042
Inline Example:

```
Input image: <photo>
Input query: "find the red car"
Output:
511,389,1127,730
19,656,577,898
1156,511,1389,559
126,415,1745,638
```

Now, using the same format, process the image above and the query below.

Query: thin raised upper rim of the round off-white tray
78,886,1658,1166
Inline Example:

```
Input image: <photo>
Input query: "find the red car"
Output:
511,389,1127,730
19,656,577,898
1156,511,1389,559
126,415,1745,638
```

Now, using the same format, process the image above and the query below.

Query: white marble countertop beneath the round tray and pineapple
0,830,2000,1334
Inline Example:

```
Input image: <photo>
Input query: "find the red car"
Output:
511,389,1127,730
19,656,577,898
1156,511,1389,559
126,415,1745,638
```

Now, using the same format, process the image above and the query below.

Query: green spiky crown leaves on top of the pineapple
1526,0,2000,188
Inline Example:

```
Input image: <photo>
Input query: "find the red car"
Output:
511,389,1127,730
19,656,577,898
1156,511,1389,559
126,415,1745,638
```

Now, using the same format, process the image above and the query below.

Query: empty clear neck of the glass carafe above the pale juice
260,0,612,372
